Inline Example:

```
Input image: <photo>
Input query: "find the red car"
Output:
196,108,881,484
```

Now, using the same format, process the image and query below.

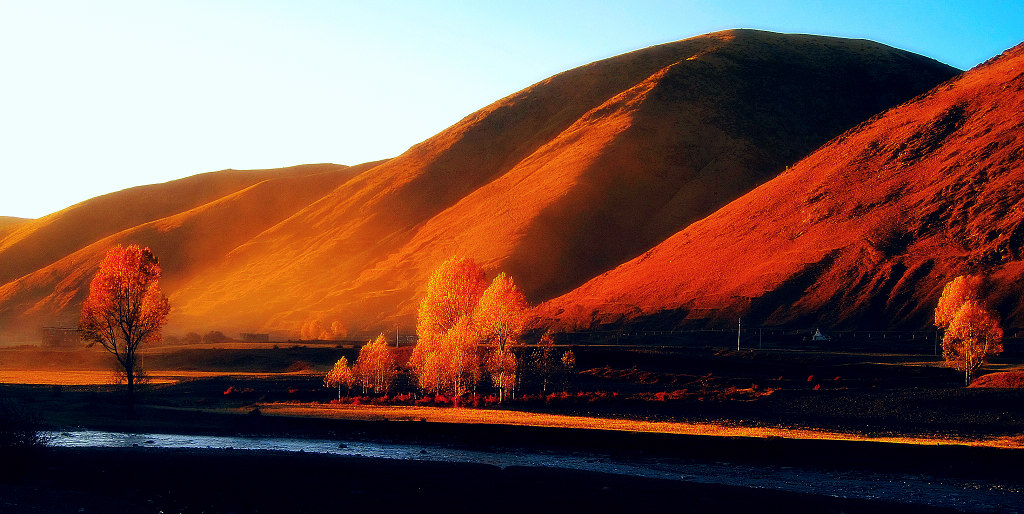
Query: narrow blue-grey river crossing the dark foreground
46,430,1024,511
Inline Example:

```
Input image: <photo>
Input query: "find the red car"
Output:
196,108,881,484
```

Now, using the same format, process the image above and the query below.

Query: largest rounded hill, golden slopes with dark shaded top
0,30,957,339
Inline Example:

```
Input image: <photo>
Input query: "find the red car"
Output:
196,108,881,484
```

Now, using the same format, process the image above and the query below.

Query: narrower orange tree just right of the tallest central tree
473,272,529,400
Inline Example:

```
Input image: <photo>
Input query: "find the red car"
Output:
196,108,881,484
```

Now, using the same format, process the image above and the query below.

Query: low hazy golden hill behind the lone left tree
0,163,376,337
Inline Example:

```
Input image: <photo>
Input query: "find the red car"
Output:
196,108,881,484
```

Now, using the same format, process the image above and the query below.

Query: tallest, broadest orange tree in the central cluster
409,258,486,392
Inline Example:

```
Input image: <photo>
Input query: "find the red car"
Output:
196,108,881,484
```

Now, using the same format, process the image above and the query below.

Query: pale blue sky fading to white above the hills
0,0,1024,218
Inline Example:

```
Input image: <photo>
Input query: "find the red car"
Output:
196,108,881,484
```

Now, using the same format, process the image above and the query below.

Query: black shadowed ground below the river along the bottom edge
0,447,974,513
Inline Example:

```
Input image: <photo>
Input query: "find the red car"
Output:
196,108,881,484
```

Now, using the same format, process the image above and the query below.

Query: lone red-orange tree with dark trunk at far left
79,245,171,408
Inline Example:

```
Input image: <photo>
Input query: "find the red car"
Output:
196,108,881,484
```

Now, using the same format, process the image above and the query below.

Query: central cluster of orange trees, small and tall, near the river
325,258,575,400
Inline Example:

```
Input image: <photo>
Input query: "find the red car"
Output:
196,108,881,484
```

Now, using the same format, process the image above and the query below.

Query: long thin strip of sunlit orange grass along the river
253,403,1024,448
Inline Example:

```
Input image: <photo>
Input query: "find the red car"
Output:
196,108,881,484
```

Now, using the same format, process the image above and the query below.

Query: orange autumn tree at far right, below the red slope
935,275,1002,386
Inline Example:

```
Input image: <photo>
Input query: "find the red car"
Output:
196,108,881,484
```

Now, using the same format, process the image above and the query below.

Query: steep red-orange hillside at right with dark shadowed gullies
538,39,1024,329
